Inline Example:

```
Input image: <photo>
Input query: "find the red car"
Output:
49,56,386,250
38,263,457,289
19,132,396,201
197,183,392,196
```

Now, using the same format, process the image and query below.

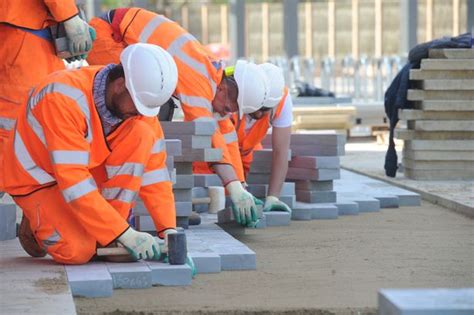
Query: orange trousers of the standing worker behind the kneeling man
0,23,65,191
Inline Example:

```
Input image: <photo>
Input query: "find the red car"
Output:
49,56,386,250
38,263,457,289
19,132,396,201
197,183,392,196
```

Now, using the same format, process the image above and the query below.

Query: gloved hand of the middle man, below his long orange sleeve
226,181,258,227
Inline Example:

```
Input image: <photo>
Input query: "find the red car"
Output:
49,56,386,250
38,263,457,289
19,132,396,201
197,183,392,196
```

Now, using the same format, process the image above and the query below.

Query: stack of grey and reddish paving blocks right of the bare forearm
263,132,345,220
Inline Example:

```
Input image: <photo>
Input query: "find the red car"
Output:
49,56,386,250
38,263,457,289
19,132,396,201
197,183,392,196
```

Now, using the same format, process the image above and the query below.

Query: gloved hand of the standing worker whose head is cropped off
64,15,95,55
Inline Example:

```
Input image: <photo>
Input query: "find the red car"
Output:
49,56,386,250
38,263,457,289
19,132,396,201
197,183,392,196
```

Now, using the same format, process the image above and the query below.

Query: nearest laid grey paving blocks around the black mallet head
65,214,257,297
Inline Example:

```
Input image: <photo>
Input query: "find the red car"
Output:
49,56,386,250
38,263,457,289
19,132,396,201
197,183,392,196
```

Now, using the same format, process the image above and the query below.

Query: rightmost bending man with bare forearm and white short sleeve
232,63,293,212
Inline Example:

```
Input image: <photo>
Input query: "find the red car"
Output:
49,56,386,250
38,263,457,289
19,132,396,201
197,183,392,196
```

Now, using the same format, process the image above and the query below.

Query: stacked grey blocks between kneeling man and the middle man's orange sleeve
161,120,222,229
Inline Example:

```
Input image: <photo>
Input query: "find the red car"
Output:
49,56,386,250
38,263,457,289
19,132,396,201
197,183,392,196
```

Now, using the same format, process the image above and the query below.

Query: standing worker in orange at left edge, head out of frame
0,0,92,191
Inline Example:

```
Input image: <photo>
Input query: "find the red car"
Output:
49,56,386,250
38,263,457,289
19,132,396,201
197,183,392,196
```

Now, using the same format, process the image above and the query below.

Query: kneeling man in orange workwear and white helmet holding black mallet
4,44,187,264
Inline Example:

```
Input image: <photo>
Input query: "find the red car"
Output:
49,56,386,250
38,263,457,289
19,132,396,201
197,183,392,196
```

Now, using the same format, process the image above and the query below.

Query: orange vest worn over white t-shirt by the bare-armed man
232,88,288,174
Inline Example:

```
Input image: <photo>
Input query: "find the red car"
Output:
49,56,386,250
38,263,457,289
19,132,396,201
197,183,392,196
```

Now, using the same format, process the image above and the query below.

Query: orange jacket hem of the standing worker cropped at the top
0,0,78,30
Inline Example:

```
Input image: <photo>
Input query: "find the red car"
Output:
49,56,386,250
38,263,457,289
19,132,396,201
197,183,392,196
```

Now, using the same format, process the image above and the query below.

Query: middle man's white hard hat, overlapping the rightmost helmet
234,60,269,118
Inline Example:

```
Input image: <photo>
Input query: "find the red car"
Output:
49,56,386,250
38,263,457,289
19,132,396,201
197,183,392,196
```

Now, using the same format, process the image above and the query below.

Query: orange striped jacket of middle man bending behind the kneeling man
87,8,243,179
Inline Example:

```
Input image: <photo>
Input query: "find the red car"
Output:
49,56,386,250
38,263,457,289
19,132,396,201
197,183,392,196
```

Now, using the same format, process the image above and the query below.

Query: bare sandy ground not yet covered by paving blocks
74,202,474,314
